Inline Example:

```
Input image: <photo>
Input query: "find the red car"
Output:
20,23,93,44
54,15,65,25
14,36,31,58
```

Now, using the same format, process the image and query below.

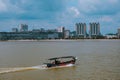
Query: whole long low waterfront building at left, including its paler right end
0,31,59,40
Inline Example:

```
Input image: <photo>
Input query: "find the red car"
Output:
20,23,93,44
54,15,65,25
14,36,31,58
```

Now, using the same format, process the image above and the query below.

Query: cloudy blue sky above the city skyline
0,0,120,34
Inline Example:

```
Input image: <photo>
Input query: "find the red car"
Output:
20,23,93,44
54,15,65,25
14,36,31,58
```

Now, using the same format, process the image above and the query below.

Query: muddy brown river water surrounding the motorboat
0,40,120,80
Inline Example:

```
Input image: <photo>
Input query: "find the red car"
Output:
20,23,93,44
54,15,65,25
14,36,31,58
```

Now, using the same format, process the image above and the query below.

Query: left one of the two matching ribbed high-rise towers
76,23,87,38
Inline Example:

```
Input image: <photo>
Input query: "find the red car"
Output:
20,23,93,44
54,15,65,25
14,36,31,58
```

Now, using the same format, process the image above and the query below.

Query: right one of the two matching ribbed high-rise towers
89,23,100,38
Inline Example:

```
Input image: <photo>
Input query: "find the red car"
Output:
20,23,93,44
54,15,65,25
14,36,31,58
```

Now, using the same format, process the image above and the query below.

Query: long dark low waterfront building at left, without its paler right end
0,31,48,40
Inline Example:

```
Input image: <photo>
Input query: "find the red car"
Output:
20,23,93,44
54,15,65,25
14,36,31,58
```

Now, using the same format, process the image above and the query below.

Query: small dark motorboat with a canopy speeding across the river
44,56,77,68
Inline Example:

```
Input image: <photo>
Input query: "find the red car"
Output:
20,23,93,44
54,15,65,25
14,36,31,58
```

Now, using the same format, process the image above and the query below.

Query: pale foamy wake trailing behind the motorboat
0,65,47,74
